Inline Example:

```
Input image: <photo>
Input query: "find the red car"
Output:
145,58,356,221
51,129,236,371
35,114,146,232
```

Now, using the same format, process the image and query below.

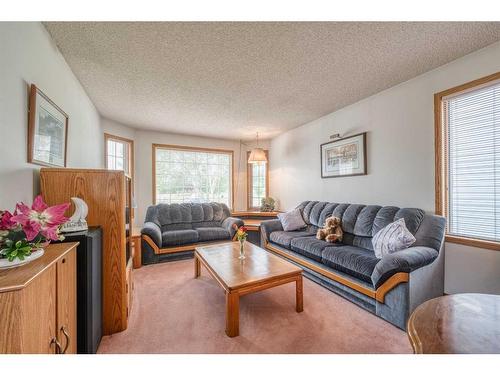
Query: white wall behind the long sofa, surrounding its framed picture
270,43,500,294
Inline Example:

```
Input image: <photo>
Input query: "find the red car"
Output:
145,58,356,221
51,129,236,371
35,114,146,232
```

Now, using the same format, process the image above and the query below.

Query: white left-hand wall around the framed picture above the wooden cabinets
0,22,104,210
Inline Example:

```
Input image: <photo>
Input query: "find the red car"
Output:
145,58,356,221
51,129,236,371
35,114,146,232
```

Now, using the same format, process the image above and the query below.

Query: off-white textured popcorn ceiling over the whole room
45,22,500,139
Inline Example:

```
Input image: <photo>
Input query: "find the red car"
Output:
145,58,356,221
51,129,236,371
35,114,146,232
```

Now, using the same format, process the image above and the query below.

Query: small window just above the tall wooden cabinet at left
104,134,134,177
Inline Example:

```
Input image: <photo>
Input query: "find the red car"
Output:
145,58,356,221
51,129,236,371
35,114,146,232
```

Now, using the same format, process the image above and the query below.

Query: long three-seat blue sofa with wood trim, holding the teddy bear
261,201,445,329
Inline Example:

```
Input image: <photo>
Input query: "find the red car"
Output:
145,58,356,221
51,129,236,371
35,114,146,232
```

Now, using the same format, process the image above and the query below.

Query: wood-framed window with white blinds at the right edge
436,73,500,248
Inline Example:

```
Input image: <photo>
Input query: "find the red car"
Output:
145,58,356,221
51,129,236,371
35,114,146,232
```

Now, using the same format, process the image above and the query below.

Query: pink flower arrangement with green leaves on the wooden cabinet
0,195,70,262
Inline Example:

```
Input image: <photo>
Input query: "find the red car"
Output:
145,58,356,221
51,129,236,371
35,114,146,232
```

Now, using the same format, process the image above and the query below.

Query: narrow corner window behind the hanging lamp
247,151,269,210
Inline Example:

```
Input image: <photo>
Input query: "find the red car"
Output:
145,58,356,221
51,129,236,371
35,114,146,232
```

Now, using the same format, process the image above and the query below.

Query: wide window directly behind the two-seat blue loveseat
153,145,233,207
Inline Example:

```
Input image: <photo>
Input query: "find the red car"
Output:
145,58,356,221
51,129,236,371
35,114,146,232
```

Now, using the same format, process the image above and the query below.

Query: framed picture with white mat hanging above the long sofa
320,132,366,178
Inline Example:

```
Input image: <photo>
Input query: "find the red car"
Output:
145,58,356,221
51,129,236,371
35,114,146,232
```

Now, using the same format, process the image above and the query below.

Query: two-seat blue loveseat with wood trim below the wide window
141,203,243,264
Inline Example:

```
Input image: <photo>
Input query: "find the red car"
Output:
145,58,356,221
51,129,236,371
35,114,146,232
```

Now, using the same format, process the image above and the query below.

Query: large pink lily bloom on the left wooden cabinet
12,195,70,241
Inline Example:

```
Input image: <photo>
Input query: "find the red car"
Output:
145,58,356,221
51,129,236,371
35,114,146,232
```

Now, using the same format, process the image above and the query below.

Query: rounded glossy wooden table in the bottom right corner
407,293,500,354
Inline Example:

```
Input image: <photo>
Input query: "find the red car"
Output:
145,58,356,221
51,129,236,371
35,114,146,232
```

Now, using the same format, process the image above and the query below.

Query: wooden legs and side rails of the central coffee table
194,244,304,337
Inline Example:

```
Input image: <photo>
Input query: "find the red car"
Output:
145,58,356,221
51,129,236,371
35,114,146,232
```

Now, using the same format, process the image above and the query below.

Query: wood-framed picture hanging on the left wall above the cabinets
28,84,69,167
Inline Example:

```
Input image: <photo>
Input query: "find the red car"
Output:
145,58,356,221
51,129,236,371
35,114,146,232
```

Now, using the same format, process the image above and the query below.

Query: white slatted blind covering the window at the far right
443,81,500,241
